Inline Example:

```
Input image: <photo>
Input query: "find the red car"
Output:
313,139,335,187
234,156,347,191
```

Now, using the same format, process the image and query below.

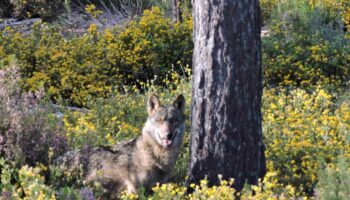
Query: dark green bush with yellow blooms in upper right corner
263,1,350,87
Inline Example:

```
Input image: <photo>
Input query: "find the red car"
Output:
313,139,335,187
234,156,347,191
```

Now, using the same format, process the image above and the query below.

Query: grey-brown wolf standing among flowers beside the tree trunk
56,94,185,199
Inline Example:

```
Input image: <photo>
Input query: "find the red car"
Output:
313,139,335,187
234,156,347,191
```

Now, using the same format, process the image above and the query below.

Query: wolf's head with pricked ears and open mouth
143,94,185,148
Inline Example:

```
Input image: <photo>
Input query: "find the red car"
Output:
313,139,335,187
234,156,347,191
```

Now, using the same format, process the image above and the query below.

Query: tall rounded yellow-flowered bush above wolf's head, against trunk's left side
111,8,193,82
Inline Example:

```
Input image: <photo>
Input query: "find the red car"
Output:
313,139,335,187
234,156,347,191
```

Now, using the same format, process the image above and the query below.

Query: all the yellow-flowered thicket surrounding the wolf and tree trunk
0,0,350,199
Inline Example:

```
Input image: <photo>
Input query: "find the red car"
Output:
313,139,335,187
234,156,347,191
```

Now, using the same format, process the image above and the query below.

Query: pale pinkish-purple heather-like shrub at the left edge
0,63,66,165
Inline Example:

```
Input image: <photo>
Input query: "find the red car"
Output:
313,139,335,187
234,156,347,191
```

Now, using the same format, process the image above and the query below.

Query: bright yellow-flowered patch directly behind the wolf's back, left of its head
63,94,146,147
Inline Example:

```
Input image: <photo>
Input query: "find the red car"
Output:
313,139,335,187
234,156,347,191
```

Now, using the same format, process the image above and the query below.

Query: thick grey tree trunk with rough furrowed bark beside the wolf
188,0,265,189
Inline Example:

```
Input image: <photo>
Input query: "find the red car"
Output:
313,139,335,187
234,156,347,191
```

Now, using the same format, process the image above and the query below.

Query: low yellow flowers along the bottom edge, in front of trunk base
121,173,300,200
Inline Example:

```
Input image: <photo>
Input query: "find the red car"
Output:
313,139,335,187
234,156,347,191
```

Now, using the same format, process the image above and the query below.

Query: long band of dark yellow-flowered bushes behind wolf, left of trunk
0,8,193,106
